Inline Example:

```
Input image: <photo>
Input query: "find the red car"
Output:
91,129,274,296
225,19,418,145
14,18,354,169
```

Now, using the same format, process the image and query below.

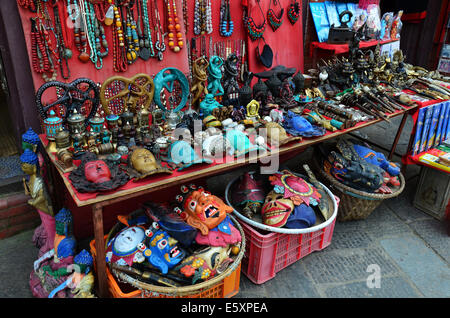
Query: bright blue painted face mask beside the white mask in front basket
137,222,186,274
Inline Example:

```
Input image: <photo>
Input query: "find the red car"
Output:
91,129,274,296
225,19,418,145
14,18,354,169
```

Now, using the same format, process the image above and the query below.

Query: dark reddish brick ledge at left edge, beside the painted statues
0,193,41,239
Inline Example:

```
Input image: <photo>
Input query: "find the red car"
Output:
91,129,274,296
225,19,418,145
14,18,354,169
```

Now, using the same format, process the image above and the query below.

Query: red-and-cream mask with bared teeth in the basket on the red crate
261,191,294,227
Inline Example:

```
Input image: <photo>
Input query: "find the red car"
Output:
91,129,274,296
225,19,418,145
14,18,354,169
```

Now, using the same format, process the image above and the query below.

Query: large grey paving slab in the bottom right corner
380,235,450,298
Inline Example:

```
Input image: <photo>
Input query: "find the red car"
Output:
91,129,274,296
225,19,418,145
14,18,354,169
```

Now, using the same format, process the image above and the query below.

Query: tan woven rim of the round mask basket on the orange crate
107,211,245,297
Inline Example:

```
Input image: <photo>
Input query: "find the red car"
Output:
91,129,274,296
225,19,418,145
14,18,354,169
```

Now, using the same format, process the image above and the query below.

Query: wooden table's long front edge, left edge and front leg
40,106,417,297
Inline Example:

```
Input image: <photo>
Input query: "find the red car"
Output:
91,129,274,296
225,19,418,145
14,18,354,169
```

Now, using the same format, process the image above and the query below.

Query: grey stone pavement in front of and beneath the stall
0,119,450,298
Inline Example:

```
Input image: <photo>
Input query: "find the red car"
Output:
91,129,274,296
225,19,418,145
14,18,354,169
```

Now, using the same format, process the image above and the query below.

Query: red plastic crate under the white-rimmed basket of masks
238,218,336,284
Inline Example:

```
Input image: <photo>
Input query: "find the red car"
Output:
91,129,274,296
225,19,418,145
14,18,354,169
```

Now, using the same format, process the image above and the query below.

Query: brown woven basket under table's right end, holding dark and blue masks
313,163,405,222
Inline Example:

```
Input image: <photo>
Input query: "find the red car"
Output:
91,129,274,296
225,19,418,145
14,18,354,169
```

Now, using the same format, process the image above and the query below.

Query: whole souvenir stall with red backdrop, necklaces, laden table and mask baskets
13,0,450,298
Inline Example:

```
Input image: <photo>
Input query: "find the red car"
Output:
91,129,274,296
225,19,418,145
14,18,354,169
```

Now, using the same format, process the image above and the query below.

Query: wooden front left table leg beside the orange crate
92,204,109,298
